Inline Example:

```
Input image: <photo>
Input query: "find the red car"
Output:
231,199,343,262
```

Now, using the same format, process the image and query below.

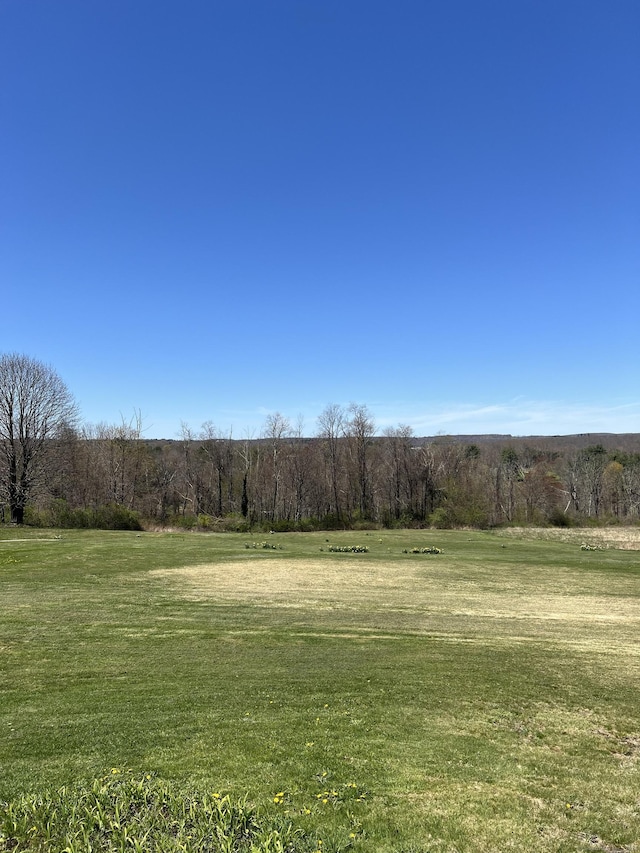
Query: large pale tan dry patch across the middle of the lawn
150,556,640,659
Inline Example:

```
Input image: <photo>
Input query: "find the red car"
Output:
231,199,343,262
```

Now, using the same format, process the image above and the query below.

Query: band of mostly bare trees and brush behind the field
0,355,640,530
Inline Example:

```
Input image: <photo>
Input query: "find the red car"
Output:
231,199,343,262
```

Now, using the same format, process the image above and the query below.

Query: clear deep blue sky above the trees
0,0,640,438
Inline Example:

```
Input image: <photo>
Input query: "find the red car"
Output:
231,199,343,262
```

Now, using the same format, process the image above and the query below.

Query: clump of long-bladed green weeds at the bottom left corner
0,768,317,853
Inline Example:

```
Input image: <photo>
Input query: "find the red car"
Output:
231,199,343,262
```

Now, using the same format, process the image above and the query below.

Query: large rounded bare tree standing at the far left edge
0,353,78,524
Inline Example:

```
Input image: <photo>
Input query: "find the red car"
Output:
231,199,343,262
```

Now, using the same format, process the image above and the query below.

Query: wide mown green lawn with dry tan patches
0,529,640,853
